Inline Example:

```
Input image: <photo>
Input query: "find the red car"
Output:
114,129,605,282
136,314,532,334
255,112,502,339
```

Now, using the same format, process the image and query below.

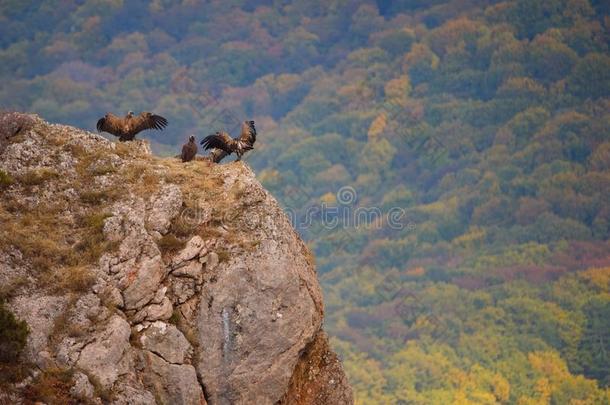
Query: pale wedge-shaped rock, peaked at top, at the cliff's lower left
76,315,132,389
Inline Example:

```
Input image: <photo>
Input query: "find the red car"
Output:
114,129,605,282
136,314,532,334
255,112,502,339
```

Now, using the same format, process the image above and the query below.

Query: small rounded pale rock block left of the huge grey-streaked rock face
140,322,193,364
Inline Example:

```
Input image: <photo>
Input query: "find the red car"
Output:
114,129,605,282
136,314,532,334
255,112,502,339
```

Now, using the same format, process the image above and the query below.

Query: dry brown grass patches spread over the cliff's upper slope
0,142,256,293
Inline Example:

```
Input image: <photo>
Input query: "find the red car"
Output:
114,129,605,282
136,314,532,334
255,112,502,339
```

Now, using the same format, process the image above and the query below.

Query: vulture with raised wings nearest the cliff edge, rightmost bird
201,121,256,163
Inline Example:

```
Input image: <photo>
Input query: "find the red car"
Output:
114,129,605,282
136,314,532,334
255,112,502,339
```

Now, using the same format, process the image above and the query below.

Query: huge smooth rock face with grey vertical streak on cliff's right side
194,166,323,404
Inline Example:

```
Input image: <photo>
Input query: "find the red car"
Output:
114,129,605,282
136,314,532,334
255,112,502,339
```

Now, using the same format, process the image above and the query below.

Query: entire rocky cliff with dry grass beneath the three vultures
0,114,353,404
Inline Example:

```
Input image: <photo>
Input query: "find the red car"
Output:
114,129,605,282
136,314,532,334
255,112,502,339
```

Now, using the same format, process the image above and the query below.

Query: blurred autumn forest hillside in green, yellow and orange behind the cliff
0,0,610,404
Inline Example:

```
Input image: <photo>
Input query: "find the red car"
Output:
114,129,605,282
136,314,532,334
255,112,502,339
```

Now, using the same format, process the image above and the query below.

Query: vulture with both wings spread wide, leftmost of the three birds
97,111,167,142
